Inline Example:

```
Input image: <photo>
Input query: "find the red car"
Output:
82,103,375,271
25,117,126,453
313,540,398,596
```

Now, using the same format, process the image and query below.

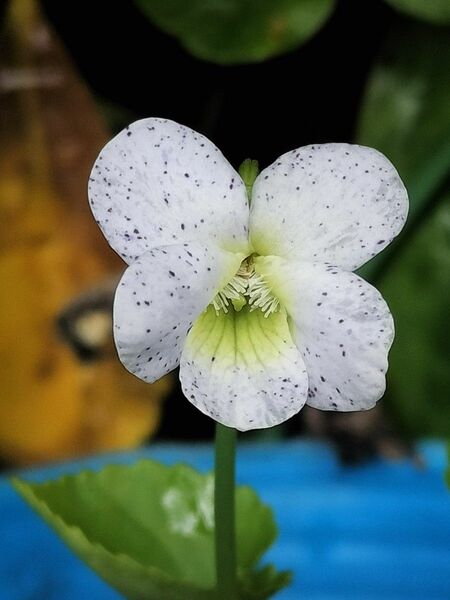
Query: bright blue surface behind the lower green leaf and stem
0,442,450,600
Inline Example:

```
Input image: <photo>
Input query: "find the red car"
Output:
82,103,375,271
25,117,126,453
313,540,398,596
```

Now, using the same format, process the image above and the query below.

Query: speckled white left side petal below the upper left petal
114,242,242,382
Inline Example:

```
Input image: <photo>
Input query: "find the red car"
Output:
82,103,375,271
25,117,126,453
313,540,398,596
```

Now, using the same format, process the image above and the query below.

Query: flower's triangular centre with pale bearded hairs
212,256,280,317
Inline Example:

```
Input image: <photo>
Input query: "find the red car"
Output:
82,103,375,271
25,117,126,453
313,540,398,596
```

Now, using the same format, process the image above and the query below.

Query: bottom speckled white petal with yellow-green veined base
180,307,308,431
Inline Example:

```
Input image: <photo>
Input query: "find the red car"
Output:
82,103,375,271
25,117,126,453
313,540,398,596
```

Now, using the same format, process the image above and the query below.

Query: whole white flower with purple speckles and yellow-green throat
89,119,408,430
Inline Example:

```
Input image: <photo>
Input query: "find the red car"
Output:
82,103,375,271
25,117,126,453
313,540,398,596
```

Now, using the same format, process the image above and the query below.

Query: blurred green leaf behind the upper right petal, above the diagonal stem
357,24,450,279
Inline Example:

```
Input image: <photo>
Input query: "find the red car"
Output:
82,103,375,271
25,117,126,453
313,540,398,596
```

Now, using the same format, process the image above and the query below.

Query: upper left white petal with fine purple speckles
89,118,248,263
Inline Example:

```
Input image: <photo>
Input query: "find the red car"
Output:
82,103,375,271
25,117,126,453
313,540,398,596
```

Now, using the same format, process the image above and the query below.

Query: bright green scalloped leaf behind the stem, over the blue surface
13,460,287,600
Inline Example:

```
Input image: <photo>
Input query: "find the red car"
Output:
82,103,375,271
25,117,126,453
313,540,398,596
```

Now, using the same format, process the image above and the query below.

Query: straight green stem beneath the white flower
214,423,237,600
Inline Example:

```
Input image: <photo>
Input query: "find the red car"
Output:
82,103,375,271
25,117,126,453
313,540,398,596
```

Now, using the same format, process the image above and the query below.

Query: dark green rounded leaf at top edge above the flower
136,0,335,65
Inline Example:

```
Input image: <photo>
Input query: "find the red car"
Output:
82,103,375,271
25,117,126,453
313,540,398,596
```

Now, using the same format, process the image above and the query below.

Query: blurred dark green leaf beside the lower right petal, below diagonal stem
379,194,450,437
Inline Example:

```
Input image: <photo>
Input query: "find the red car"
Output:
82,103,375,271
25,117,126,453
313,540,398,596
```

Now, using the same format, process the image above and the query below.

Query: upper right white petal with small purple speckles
250,144,408,270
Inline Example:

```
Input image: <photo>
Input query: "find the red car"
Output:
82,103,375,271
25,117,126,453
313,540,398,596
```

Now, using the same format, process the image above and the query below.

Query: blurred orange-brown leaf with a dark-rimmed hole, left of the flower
0,0,168,463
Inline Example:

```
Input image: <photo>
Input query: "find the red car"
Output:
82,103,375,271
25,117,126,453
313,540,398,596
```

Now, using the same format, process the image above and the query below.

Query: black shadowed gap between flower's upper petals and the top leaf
43,0,399,171
